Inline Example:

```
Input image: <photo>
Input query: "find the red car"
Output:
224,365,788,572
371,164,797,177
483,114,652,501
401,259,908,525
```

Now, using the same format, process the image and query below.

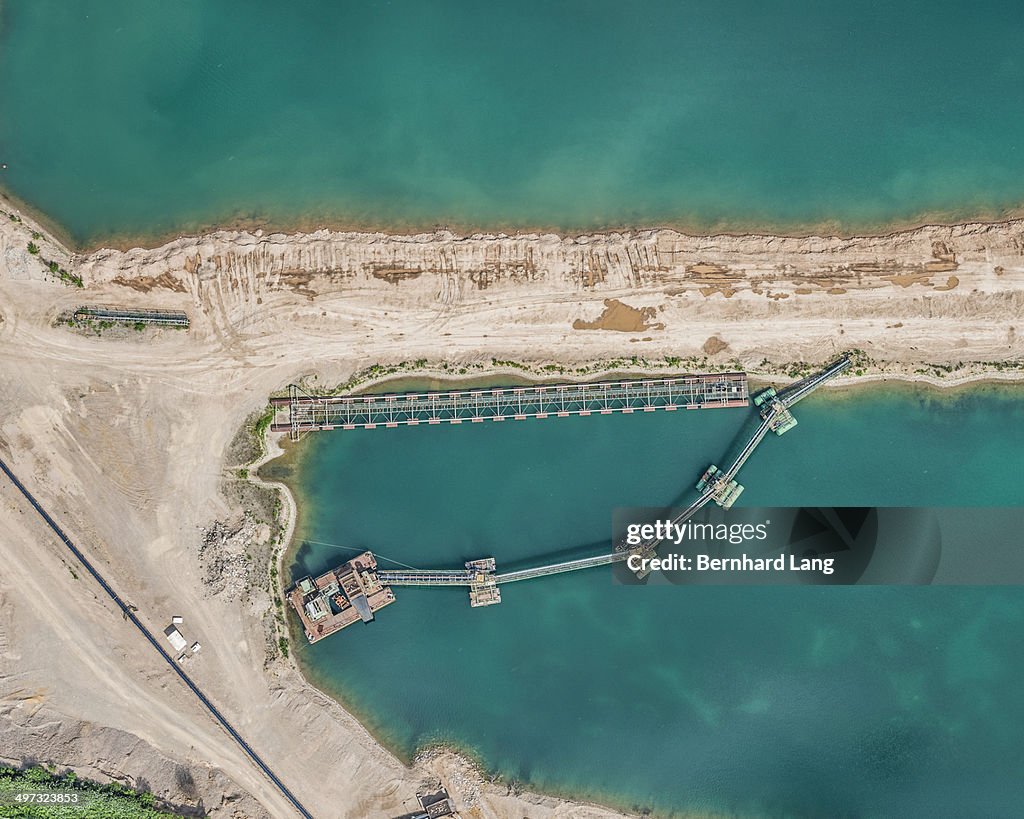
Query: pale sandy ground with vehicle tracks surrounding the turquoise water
0,202,1024,819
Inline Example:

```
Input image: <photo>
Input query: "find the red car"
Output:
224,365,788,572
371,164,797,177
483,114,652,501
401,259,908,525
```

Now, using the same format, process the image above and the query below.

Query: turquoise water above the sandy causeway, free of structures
0,0,1024,243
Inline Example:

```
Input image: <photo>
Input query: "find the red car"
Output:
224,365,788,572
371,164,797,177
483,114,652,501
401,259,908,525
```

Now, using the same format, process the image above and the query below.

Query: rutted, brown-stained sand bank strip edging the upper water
75,222,1024,311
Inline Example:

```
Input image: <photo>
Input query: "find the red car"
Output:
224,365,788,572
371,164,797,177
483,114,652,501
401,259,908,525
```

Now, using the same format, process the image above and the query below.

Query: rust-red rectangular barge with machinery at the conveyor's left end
287,552,394,643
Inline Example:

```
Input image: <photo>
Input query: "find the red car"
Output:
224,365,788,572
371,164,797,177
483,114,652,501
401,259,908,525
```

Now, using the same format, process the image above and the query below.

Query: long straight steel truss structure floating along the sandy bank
270,373,750,440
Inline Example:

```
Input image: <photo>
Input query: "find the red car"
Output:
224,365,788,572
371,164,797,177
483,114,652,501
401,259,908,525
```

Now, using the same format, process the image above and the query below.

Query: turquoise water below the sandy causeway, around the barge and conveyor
293,388,1024,817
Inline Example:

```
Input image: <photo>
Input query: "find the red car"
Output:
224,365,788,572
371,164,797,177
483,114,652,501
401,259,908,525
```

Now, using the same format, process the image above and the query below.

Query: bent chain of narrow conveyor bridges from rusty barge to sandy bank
364,355,851,602
